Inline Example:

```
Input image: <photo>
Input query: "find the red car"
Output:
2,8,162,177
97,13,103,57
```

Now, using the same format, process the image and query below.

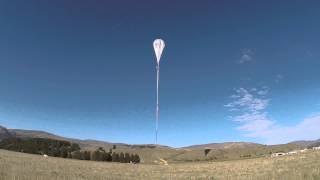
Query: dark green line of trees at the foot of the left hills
0,138,140,163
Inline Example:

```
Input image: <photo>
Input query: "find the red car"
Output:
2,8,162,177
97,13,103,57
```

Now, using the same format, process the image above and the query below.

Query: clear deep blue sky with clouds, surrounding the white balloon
0,0,320,147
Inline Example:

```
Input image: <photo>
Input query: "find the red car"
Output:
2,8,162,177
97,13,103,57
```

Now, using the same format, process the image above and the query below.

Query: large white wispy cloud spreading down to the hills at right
225,88,320,144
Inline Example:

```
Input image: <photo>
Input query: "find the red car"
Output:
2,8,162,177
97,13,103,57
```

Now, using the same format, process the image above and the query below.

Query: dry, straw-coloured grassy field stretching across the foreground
0,150,320,180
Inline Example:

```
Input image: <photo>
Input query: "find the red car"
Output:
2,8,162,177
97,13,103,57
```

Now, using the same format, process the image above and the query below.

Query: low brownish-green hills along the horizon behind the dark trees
0,127,312,164
